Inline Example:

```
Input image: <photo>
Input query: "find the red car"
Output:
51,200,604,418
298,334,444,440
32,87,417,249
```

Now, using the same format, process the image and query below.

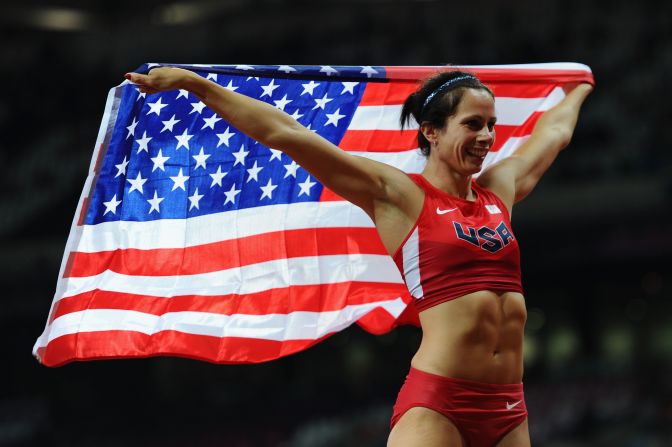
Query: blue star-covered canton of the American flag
84,67,372,224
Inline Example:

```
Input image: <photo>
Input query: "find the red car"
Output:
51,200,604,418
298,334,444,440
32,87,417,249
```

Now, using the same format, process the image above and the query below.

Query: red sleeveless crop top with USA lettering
393,174,523,311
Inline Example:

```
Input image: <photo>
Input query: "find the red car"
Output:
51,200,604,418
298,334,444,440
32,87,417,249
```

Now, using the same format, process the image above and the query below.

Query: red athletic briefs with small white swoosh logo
390,368,527,447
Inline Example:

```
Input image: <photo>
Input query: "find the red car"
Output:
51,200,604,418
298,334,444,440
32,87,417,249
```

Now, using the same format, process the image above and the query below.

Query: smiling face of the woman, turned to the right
423,89,497,176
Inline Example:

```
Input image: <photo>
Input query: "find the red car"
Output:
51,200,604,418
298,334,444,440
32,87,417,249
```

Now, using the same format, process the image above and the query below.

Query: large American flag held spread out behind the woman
33,63,592,366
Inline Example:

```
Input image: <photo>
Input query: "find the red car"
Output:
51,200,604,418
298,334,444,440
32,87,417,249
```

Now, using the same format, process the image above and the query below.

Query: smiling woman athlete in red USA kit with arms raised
126,68,592,447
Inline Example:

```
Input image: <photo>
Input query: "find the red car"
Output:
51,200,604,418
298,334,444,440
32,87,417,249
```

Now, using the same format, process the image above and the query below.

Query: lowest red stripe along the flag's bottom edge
37,331,332,367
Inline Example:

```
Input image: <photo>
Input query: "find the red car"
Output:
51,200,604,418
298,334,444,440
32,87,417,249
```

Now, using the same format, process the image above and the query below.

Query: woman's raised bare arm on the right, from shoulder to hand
478,84,593,206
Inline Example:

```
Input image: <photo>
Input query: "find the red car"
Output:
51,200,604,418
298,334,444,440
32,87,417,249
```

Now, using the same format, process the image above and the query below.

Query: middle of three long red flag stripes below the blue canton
50,281,408,322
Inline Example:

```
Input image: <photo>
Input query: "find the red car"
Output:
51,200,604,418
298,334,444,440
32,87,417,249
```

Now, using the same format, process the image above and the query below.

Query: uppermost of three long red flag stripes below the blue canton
65,228,387,277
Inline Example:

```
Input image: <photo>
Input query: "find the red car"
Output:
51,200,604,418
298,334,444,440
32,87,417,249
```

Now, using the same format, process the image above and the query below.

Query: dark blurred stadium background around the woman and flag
0,0,672,447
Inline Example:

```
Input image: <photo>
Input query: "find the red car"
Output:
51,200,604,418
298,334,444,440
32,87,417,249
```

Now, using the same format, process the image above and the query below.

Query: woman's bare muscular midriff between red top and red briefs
411,290,527,383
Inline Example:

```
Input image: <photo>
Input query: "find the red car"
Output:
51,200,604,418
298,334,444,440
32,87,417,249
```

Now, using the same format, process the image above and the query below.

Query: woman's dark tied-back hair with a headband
399,71,495,157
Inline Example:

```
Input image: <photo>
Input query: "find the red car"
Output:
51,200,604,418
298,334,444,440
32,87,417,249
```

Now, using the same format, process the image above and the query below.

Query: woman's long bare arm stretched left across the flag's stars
126,67,410,220
